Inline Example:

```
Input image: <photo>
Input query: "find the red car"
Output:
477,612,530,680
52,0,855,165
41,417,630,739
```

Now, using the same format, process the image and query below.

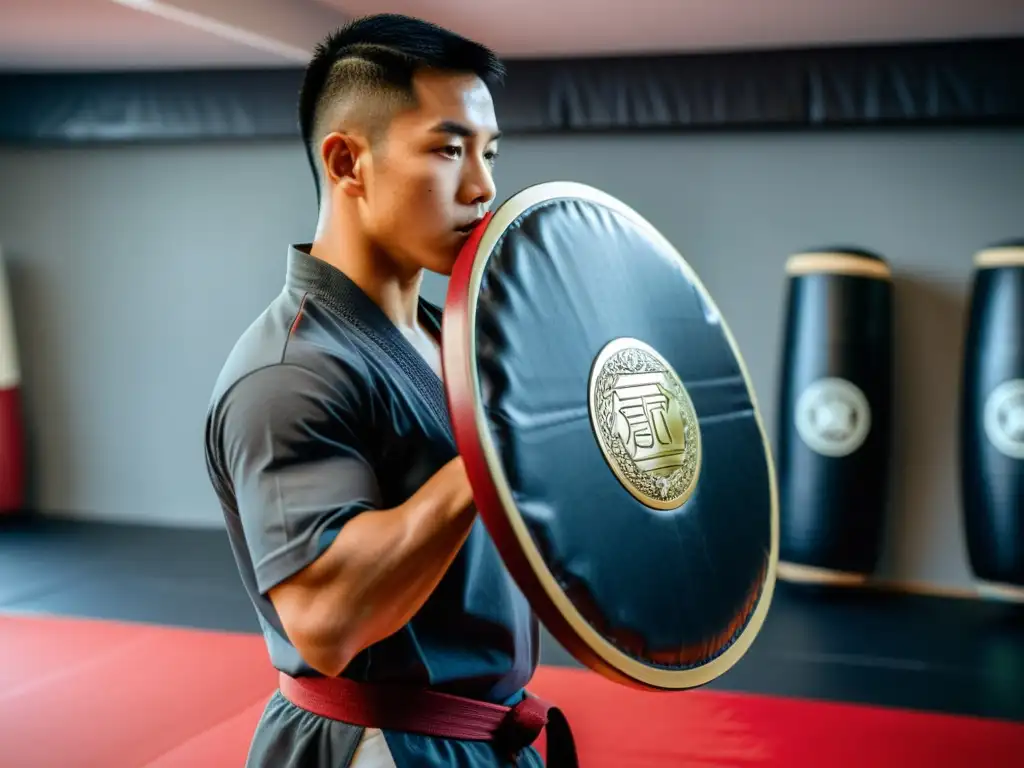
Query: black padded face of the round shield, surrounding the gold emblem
454,186,777,687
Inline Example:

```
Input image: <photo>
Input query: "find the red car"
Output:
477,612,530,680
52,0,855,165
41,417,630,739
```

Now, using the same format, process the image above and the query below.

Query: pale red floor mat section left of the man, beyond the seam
0,617,275,768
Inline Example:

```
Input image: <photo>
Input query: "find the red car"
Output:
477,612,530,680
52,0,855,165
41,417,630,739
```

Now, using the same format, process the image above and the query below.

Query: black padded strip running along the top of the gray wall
0,38,1024,143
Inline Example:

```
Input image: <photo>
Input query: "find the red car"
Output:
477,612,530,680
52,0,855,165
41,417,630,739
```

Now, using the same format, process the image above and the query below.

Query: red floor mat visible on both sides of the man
0,617,1024,768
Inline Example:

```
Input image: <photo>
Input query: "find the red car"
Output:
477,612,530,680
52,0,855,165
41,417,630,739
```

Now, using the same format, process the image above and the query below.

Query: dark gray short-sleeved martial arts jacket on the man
198,246,538,765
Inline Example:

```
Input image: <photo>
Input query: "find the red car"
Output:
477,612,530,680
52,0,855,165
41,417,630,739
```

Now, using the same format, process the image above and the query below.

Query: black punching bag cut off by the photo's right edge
959,241,1024,600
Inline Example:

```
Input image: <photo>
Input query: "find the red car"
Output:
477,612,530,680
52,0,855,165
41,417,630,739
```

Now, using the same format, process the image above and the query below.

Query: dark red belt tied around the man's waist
280,674,579,768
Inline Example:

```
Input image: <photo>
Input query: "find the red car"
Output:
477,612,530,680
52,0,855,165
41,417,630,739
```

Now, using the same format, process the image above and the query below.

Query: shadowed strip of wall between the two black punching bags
879,272,969,584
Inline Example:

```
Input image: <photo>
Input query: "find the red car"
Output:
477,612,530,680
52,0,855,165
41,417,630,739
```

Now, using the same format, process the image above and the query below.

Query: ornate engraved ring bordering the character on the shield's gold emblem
595,348,697,502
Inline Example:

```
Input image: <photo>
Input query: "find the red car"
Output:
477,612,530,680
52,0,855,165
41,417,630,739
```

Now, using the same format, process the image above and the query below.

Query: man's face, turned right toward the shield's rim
360,73,499,274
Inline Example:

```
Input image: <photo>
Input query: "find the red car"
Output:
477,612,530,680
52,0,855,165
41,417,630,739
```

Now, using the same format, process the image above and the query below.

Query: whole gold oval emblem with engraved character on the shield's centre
590,338,701,509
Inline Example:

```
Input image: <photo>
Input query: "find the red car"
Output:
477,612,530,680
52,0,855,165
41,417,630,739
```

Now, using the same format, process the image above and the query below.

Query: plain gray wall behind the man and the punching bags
0,132,1024,586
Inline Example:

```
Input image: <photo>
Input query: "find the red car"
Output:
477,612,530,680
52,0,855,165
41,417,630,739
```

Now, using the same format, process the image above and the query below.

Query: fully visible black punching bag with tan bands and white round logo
776,248,893,585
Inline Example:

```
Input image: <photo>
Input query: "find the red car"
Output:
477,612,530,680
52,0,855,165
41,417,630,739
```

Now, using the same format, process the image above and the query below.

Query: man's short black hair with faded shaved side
299,13,505,200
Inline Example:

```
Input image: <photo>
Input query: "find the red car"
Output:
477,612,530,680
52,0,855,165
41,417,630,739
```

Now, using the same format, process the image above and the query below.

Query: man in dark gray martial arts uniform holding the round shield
206,14,541,768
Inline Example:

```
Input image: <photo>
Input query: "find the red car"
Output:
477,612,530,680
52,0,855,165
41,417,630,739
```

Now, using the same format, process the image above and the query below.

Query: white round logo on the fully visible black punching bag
796,378,871,457
